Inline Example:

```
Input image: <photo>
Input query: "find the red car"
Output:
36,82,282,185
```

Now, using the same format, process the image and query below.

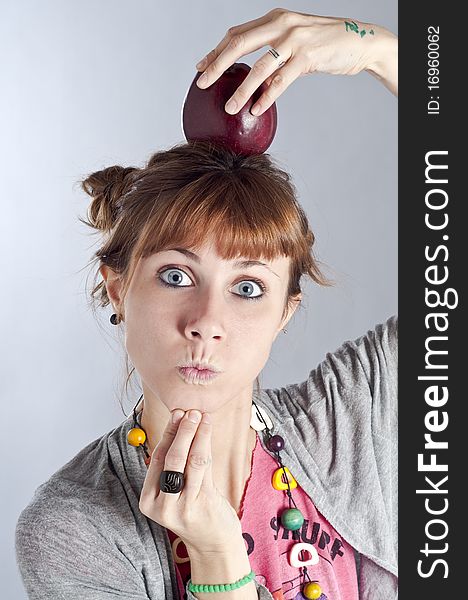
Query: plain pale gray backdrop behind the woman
0,0,398,600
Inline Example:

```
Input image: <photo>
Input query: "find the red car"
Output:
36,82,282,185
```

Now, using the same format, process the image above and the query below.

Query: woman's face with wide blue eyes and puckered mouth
104,237,297,412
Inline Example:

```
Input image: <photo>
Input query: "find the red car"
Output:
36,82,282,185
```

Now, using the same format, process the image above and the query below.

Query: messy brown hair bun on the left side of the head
81,165,139,231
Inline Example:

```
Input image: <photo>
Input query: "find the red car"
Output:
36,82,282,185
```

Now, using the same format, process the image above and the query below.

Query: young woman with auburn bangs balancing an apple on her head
16,9,397,600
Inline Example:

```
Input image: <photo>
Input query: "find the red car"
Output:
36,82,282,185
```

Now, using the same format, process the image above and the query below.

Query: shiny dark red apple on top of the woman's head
182,63,277,156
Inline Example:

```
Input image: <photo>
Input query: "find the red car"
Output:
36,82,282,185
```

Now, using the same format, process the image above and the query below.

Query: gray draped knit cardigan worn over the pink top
16,317,398,600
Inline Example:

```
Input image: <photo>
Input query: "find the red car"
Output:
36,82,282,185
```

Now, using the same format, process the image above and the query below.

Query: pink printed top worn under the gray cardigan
168,434,358,600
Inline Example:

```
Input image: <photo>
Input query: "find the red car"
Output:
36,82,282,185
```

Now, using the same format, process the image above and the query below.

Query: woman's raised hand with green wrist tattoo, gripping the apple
192,8,398,115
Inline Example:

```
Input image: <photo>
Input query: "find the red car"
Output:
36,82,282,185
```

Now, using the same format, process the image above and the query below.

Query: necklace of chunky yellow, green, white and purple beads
127,394,326,600
